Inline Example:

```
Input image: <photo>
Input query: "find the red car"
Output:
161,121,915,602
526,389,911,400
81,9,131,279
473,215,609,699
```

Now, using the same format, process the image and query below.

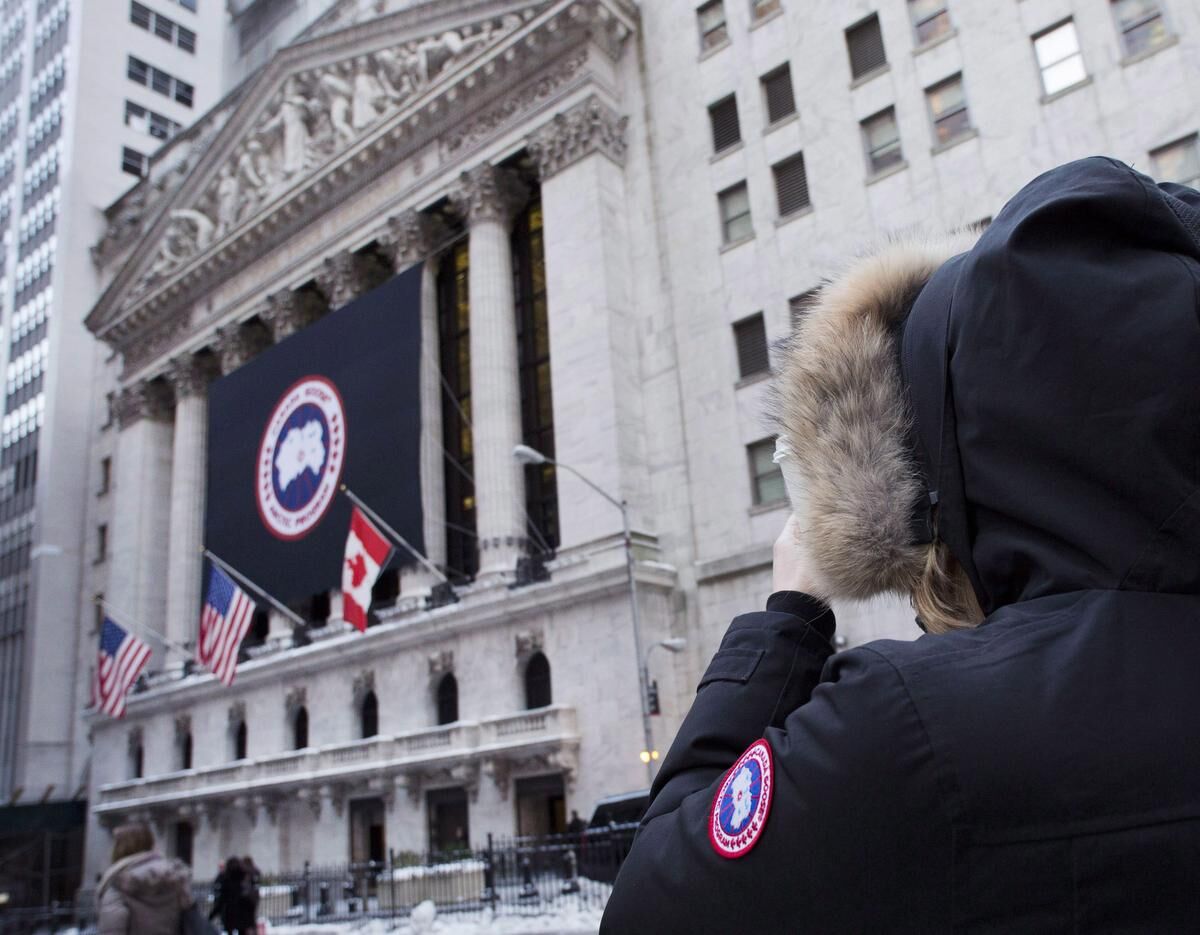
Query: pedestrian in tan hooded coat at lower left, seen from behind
96,823,193,935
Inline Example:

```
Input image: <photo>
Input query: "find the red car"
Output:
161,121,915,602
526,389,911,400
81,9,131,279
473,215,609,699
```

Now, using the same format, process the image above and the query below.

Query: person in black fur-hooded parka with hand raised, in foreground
601,157,1200,935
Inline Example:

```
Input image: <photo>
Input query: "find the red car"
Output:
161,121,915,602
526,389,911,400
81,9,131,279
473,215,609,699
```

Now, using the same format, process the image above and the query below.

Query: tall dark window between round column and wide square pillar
512,193,559,555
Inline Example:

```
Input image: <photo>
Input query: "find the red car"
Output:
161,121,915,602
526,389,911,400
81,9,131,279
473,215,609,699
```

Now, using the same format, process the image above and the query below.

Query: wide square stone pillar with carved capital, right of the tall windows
528,95,648,551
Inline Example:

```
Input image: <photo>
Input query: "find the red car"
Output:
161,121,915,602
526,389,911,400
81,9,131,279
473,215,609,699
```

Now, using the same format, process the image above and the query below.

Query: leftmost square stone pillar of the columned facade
104,380,172,648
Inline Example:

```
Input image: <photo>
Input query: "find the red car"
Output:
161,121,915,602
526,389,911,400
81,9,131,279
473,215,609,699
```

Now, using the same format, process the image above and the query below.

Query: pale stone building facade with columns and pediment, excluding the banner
79,0,1200,873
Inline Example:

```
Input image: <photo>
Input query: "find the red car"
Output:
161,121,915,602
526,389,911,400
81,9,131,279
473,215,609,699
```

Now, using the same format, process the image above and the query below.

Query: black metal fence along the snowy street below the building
0,825,637,935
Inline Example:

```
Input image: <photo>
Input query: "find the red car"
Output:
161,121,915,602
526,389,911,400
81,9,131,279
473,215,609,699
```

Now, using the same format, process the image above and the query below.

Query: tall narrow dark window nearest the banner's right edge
438,240,479,582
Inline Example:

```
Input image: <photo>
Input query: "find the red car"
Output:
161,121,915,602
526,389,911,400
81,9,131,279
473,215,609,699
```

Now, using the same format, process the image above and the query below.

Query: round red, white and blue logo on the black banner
254,377,346,539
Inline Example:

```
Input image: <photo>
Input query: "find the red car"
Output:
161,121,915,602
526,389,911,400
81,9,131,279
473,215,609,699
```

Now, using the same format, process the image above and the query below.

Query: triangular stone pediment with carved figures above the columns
88,0,636,357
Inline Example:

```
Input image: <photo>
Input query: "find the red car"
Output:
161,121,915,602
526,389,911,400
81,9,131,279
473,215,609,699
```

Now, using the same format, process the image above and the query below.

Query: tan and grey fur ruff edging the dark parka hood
774,234,977,600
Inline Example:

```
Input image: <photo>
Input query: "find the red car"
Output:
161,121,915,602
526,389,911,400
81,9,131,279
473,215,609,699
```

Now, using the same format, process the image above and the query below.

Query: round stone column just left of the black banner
167,355,212,663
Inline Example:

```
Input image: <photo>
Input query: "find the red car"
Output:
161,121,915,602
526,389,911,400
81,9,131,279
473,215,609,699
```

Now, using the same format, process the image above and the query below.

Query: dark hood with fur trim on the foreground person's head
774,158,1200,613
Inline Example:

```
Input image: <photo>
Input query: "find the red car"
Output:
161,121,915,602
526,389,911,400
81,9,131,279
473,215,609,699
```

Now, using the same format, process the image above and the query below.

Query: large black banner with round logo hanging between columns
204,266,425,601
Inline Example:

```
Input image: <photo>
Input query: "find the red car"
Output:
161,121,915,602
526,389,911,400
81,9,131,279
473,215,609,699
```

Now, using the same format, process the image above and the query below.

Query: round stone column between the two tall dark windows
451,163,528,581
